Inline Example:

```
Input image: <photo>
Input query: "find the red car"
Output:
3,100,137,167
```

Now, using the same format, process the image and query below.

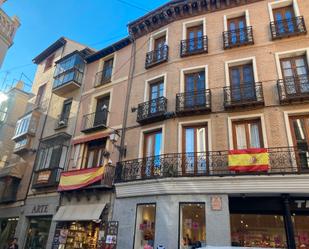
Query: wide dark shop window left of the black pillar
231,214,287,248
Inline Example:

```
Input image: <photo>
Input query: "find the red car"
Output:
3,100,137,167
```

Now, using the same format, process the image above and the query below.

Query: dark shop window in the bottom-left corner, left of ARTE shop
0,218,18,249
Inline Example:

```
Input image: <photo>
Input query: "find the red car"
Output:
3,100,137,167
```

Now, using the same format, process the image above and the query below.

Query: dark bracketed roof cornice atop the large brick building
128,0,265,38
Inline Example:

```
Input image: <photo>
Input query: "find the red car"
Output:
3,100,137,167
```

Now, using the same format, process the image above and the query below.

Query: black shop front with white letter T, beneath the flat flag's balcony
229,196,309,249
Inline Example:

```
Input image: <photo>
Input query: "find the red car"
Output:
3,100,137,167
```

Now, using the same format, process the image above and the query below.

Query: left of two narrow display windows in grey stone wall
134,204,156,249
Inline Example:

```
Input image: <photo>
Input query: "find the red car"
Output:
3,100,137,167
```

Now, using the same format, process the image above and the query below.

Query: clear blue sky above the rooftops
0,0,168,90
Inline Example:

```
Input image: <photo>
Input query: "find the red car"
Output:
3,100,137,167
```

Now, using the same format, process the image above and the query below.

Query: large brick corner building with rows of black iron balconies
113,0,309,249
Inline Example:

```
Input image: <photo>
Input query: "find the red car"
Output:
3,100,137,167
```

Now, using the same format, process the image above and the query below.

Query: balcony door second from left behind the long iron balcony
182,125,208,175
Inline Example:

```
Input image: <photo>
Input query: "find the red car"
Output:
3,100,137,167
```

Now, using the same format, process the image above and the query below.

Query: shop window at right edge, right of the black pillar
292,214,309,249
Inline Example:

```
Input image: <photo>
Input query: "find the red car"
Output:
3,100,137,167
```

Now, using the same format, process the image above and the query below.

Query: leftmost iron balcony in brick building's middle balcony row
136,97,167,124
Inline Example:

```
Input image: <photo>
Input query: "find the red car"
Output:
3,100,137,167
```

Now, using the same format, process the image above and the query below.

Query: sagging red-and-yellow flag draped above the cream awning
58,167,104,191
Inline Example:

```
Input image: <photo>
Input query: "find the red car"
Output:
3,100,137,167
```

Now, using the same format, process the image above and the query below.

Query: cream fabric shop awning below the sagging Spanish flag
53,203,106,221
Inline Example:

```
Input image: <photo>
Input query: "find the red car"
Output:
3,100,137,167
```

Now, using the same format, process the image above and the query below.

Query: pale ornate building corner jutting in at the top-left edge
0,0,20,67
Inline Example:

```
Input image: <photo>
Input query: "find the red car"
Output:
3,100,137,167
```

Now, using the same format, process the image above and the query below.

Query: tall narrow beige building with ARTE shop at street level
0,38,93,248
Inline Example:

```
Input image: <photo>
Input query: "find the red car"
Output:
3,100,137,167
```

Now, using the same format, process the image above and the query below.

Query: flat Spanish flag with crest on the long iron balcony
228,149,269,172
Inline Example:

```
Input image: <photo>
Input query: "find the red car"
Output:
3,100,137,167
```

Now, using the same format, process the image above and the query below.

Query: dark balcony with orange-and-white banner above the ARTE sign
32,168,63,189
